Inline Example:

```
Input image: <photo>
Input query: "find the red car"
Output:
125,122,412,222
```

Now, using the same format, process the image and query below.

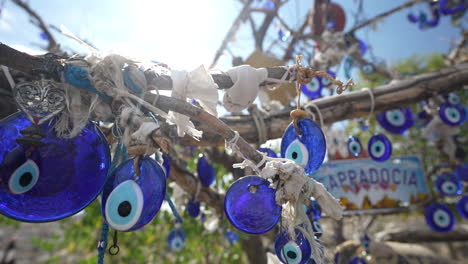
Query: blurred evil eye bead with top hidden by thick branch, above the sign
376,107,414,134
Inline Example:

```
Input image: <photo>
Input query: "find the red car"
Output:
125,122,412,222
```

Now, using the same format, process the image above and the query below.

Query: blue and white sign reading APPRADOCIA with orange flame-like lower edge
313,156,429,210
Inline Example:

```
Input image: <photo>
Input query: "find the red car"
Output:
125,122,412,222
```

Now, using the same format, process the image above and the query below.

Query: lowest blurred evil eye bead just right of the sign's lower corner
425,203,455,232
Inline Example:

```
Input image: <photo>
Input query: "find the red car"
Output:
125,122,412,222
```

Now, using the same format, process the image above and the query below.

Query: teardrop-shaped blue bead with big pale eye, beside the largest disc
101,157,166,232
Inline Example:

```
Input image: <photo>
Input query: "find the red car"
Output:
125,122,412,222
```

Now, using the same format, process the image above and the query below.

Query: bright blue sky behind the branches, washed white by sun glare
0,0,459,70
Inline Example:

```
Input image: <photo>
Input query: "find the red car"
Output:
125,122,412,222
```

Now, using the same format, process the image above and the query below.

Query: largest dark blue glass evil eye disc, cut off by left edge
0,113,110,223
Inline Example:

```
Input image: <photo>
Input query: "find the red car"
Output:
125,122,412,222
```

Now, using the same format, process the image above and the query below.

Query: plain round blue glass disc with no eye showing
224,176,281,234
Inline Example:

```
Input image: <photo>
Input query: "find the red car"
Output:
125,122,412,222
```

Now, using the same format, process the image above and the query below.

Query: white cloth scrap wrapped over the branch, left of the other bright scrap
168,65,218,139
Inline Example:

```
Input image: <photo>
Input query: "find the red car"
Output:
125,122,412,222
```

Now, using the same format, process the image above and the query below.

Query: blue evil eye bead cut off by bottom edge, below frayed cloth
275,229,312,264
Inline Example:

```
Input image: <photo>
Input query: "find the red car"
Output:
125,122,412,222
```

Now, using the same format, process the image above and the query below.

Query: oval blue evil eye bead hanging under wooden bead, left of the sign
281,118,327,175
